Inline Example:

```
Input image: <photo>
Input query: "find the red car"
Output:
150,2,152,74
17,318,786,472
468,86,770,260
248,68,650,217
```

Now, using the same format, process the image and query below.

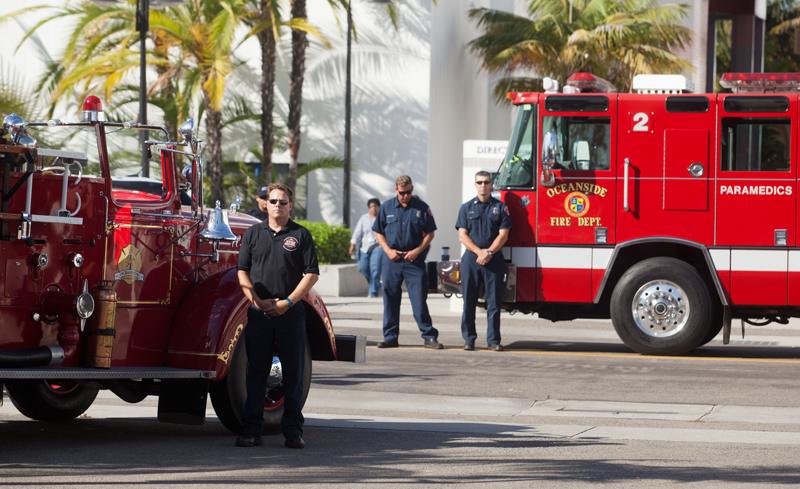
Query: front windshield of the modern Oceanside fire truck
498,104,536,188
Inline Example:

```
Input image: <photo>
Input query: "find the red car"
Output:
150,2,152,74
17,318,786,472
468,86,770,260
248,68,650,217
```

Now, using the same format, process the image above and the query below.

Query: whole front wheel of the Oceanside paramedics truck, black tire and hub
611,257,715,355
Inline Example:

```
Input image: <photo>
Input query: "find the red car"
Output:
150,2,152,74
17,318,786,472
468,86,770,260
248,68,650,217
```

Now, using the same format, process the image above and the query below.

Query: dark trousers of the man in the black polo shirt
242,304,306,437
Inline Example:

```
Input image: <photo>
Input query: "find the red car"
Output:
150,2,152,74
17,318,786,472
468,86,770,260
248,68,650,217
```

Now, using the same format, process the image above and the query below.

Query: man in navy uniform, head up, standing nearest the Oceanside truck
456,171,511,351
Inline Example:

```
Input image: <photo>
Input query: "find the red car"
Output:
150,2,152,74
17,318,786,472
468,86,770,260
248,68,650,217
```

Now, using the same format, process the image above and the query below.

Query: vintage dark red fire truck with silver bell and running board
0,96,366,433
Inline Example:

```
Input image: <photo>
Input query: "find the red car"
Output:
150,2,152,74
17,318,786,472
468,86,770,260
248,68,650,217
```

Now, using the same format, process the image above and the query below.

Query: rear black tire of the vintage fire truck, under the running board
6,379,97,421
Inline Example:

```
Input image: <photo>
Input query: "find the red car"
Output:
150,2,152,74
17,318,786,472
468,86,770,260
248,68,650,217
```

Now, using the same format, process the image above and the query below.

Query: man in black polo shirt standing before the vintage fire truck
236,183,319,448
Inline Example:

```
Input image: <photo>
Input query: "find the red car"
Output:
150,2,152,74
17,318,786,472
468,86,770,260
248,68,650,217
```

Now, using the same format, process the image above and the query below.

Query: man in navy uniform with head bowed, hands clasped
372,175,442,350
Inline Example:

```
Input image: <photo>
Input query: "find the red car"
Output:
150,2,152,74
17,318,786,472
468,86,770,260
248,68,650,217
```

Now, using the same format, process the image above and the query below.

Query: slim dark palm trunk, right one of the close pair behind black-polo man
288,0,308,214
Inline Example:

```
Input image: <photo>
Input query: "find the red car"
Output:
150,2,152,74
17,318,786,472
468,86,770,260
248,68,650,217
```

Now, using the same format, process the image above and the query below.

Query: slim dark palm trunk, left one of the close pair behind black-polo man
256,0,275,185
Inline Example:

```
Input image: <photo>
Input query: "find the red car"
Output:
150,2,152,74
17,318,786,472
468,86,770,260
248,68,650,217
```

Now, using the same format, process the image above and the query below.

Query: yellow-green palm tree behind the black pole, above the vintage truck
9,0,268,201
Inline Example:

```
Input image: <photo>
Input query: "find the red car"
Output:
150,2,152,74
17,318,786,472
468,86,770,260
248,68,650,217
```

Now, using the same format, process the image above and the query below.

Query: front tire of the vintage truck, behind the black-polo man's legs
209,335,311,435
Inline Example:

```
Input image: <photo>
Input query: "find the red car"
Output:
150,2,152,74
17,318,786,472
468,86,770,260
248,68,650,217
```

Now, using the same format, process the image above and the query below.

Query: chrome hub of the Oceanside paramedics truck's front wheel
631,280,689,338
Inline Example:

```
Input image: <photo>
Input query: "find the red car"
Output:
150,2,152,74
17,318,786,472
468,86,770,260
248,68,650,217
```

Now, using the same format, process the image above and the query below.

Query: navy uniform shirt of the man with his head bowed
372,197,436,251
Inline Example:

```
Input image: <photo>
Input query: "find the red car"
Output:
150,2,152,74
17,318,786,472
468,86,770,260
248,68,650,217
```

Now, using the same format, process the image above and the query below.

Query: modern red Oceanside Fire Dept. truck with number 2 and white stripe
437,73,800,355
